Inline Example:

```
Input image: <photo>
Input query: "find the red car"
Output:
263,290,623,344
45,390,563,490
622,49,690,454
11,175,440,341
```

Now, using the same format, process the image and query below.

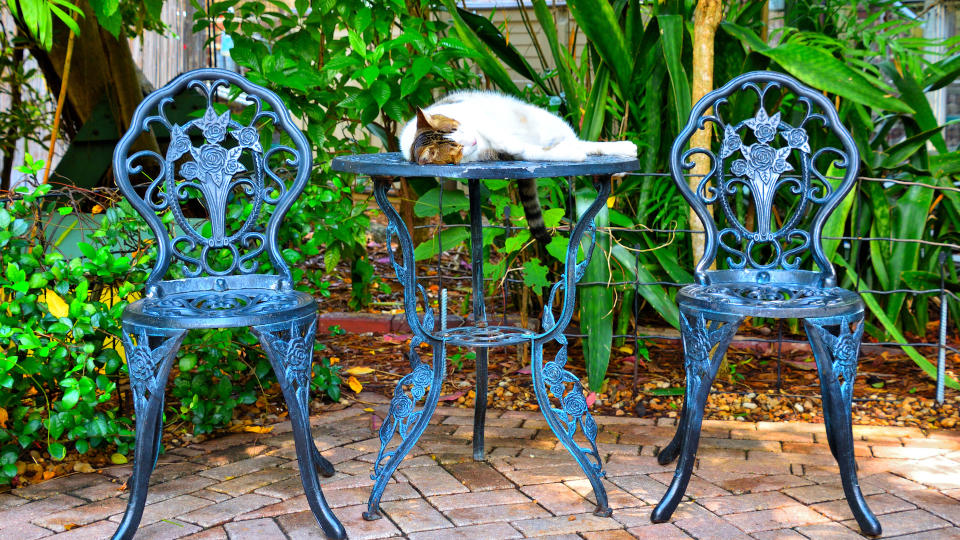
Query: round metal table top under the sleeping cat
331,152,640,180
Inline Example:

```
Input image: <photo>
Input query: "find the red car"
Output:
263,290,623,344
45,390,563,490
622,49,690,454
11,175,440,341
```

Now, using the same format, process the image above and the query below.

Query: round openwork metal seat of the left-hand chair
123,288,317,328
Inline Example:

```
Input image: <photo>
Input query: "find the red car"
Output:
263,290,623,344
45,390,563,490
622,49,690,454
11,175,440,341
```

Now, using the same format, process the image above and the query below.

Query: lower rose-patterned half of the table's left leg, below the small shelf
363,342,447,521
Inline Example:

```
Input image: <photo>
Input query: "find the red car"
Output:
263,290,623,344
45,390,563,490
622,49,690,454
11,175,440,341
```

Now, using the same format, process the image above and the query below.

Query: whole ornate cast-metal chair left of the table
113,69,346,539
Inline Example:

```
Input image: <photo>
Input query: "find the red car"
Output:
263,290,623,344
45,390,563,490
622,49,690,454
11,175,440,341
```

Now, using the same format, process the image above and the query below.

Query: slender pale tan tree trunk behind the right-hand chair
688,0,723,263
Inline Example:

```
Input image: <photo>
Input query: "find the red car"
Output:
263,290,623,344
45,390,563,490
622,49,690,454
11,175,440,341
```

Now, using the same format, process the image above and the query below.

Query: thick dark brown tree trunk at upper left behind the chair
21,0,159,184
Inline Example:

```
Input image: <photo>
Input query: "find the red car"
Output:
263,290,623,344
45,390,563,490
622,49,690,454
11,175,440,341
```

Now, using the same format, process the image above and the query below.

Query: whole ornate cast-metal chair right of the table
651,72,881,535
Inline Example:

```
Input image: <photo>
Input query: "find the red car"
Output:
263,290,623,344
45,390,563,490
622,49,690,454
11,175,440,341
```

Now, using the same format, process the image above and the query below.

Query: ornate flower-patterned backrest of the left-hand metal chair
113,69,312,295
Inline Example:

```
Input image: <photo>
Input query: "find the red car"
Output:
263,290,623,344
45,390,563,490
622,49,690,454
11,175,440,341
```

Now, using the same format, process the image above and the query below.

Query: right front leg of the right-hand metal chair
803,312,882,536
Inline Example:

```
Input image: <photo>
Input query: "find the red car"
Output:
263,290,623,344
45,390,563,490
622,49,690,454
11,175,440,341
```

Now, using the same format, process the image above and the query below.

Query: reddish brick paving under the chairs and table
0,394,960,540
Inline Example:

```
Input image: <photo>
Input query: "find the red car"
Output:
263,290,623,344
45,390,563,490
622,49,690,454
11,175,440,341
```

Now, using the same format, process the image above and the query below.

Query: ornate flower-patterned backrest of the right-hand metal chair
670,75,860,292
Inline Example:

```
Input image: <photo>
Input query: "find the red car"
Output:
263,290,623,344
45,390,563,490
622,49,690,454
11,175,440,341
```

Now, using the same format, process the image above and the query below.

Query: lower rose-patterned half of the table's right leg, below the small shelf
530,334,613,517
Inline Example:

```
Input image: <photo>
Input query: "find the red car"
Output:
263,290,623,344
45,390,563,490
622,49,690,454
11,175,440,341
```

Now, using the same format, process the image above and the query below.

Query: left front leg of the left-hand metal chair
113,323,186,540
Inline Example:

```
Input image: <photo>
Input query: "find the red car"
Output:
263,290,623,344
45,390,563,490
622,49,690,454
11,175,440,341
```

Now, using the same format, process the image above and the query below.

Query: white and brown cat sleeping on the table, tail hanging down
400,91,637,245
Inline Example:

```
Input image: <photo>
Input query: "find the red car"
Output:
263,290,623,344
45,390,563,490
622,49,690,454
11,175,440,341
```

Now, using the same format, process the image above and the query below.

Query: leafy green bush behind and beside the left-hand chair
0,173,340,484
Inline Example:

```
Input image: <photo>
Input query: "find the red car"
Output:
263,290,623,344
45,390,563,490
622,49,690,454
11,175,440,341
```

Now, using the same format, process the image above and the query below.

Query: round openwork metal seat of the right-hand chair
677,283,864,319
